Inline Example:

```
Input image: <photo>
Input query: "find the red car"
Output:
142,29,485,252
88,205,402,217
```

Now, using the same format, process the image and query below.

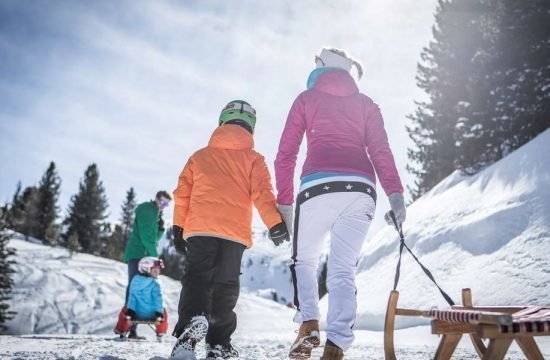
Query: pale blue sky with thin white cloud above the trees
0,0,437,238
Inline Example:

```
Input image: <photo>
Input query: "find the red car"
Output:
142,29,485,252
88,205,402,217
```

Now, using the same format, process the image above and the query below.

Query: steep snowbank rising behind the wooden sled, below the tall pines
344,130,550,329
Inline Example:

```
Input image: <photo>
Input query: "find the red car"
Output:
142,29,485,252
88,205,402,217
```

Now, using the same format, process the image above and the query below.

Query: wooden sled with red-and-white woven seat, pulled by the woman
384,289,550,360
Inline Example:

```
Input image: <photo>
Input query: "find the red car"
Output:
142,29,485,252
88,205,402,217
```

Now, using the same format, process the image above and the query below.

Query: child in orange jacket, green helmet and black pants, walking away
172,100,290,359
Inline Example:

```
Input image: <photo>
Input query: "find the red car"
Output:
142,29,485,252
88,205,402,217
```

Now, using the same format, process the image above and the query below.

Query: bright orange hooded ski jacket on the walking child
174,124,283,247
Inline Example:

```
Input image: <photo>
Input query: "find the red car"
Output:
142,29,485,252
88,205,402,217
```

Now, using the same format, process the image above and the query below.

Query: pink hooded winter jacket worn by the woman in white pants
275,70,403,205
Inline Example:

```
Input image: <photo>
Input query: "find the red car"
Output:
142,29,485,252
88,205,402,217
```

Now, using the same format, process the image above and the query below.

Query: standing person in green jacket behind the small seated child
124,191,172,338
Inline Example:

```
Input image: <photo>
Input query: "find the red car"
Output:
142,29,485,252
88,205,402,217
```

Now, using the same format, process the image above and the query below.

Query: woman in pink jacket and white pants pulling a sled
275,49,405,360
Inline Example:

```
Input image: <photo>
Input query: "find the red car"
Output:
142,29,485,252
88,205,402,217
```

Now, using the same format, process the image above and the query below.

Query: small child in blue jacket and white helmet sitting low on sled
115,256,168,338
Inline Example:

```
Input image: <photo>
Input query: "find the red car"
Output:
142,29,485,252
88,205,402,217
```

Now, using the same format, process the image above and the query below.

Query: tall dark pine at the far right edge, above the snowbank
457,0,550,174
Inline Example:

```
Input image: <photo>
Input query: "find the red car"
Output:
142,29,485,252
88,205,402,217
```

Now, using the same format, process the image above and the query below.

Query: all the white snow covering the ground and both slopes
0,130,550,360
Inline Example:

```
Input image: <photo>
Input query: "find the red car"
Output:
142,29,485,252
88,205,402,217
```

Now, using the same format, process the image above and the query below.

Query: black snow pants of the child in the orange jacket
172,236,246,345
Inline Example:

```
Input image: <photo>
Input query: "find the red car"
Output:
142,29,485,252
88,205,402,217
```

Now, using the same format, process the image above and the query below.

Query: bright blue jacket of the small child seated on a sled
126,274,164,320
